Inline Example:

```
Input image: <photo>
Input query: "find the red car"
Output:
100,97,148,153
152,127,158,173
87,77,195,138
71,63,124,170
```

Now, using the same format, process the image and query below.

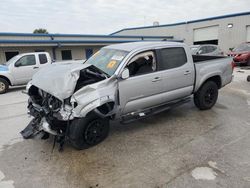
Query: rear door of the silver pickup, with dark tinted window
157,47,195,102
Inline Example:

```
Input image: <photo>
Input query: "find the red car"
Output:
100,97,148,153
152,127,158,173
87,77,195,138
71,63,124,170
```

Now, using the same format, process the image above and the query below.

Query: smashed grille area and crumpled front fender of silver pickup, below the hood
21,67,117,151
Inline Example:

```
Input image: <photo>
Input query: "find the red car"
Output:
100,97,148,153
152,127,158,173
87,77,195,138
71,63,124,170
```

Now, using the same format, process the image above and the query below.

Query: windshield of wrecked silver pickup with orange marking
86,48,128,76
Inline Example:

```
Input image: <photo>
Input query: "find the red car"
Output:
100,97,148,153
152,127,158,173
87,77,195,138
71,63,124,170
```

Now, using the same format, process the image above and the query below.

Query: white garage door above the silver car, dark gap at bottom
194,26,219,44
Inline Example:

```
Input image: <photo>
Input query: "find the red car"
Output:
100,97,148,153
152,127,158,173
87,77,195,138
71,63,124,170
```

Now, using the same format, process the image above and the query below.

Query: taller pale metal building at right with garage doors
111,12,250,52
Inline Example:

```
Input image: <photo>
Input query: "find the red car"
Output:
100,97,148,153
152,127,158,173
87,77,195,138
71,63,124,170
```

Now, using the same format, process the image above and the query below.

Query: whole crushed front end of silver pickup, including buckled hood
21,59,117,149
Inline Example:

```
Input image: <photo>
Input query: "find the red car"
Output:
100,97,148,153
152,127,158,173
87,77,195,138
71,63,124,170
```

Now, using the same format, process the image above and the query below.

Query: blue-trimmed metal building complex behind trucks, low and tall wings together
0,12,250,64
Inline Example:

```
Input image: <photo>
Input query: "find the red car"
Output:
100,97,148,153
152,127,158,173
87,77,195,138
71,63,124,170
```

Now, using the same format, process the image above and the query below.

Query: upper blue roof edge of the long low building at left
0,32,174,39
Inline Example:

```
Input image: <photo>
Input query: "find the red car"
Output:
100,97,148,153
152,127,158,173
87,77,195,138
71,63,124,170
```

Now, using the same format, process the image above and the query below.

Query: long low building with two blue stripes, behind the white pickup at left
0,33,176,64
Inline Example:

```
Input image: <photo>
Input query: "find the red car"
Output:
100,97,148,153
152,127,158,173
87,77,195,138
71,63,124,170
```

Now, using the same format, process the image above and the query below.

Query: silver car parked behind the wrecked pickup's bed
190,44,224,56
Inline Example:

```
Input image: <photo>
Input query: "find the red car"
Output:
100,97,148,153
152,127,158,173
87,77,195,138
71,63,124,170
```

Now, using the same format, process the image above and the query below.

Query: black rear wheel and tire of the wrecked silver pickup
194,81,218,110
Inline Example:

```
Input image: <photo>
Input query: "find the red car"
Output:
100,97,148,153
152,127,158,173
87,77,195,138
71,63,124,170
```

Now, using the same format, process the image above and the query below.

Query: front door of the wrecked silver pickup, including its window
118,51,162,114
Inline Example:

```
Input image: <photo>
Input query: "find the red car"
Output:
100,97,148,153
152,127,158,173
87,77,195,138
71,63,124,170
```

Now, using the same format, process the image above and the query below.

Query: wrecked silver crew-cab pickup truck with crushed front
21,42,233,149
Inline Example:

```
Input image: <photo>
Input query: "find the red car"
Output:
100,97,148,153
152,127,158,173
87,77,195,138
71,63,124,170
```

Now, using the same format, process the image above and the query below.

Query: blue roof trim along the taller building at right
110,12,250,36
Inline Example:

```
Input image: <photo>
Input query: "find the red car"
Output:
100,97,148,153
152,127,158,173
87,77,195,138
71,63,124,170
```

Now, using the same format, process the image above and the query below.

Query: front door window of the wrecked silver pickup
126,51,156,77
